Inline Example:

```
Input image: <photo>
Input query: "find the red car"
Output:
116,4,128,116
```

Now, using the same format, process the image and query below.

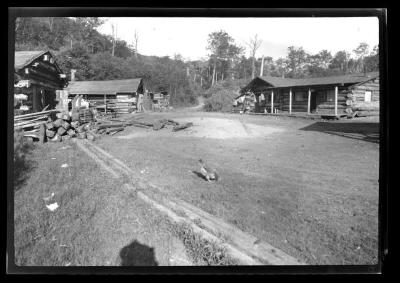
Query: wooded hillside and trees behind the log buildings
15,17,379,105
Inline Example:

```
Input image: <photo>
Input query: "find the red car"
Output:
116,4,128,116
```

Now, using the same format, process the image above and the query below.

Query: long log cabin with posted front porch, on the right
236,72,379,115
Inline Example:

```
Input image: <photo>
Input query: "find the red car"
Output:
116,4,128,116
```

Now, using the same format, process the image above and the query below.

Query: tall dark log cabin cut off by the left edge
14,51,67,114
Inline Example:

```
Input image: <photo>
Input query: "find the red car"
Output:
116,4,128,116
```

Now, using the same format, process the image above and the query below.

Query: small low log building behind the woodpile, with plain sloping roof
65,78,145,113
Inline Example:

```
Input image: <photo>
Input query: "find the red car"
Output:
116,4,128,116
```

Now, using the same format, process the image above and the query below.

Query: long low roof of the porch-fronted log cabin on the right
246,72,379,88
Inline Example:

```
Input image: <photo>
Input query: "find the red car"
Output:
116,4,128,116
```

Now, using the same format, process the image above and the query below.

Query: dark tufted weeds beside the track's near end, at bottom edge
172,223,238,265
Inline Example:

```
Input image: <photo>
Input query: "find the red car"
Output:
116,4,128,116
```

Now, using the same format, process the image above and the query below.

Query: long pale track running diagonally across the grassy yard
72,141,304,265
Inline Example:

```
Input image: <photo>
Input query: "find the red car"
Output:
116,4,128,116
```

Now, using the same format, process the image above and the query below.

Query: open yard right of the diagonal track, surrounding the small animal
96,112,379,264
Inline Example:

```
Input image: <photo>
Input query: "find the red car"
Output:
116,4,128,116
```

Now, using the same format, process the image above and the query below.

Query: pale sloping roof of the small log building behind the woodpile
67,78,142,94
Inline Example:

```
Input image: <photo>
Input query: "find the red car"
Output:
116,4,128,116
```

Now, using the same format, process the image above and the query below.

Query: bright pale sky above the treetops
98,17,379,60
